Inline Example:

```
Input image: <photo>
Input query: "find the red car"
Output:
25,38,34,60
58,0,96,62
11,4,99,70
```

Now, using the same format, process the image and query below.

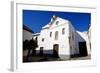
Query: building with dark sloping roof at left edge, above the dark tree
23,25,34,41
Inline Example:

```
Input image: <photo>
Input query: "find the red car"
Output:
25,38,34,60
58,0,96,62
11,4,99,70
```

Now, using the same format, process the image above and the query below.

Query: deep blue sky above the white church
23,10,91,32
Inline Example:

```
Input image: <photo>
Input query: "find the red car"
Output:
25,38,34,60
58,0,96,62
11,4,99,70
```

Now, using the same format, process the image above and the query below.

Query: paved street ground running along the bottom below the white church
24,55,91,62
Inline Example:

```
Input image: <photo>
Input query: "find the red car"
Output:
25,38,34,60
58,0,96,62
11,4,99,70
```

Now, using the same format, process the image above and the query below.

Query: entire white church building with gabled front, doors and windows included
33,15,90,59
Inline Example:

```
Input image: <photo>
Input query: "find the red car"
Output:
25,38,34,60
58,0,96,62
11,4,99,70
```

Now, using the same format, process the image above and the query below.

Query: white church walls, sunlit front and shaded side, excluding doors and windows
37,17,90,59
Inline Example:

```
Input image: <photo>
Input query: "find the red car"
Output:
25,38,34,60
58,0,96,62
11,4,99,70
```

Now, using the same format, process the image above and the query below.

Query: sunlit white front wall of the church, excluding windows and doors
37,17,70,58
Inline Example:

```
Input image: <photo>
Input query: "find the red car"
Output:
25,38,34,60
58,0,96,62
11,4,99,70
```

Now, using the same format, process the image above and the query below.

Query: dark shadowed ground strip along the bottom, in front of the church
23,55,91,63
